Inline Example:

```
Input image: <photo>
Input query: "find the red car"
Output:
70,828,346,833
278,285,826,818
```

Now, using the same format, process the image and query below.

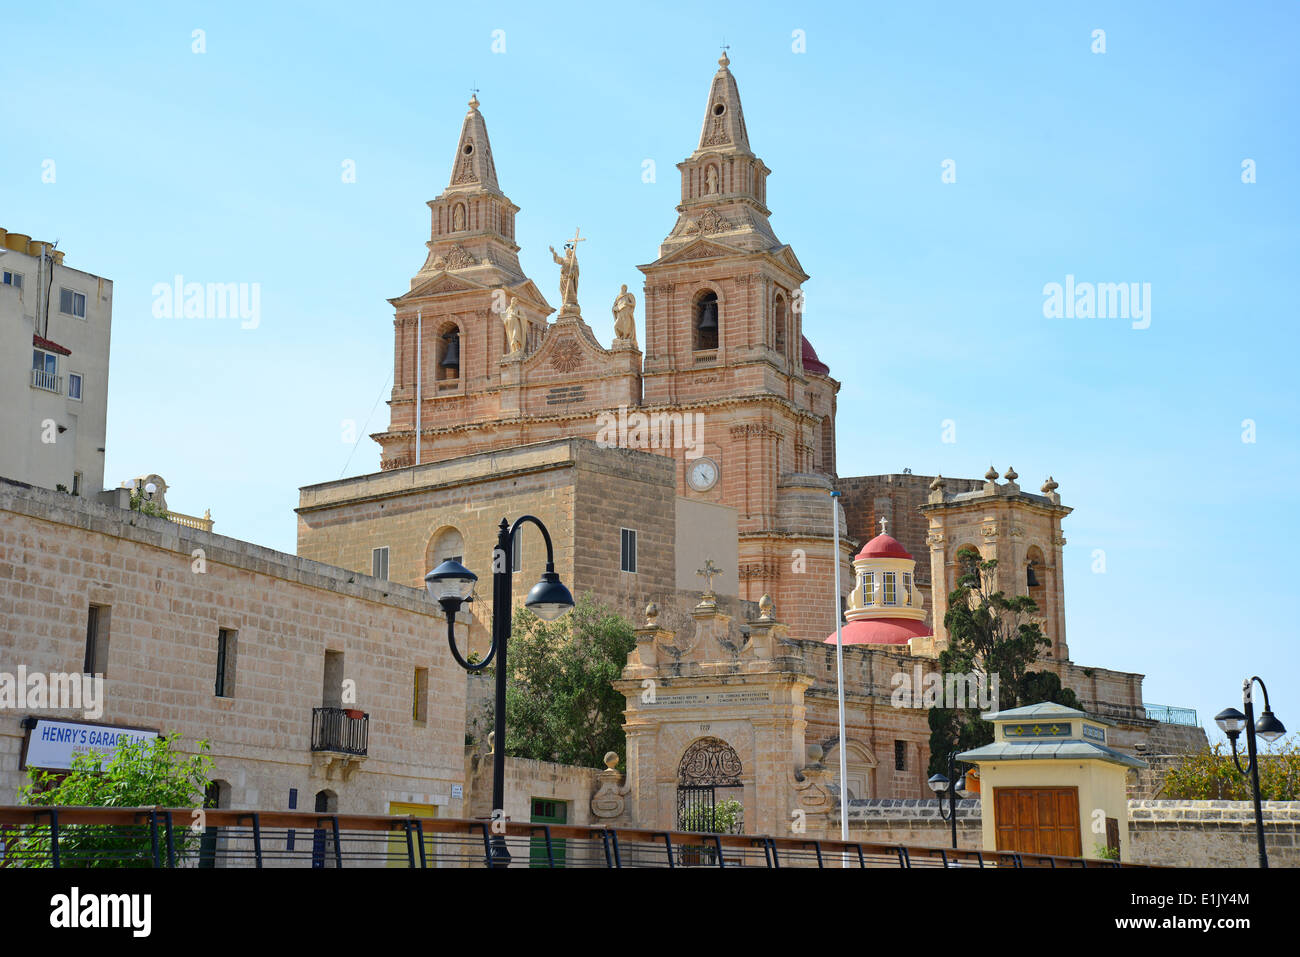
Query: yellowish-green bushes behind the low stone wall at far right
1160,735,1300,801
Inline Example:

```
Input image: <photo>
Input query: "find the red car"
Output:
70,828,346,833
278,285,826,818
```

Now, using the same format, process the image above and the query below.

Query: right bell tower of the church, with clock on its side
640,53,853,640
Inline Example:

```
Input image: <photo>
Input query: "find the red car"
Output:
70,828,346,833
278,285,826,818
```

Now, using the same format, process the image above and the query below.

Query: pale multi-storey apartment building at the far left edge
0,229,113,495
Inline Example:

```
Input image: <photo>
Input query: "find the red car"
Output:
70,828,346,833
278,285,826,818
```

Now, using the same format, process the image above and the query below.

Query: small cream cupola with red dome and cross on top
827,520,931,645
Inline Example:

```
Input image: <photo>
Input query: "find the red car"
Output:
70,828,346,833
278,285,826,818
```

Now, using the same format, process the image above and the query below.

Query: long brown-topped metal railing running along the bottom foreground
0,805,1135,870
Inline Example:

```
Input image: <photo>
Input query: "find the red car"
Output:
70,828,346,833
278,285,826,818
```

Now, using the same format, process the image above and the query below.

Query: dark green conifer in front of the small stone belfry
930,553,1083,774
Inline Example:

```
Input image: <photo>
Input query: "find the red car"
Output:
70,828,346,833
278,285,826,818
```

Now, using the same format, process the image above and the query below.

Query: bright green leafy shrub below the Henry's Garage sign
5,735,212,867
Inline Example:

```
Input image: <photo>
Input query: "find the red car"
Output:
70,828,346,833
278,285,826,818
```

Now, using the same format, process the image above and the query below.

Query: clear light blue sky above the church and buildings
0,1,1300,729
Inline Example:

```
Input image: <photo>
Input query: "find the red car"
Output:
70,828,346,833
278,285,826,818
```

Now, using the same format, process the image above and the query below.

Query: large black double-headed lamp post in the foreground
424,515,573,867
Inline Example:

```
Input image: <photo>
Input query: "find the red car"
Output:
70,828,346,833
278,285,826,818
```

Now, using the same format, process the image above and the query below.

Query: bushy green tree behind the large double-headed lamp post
493,594,637,767
